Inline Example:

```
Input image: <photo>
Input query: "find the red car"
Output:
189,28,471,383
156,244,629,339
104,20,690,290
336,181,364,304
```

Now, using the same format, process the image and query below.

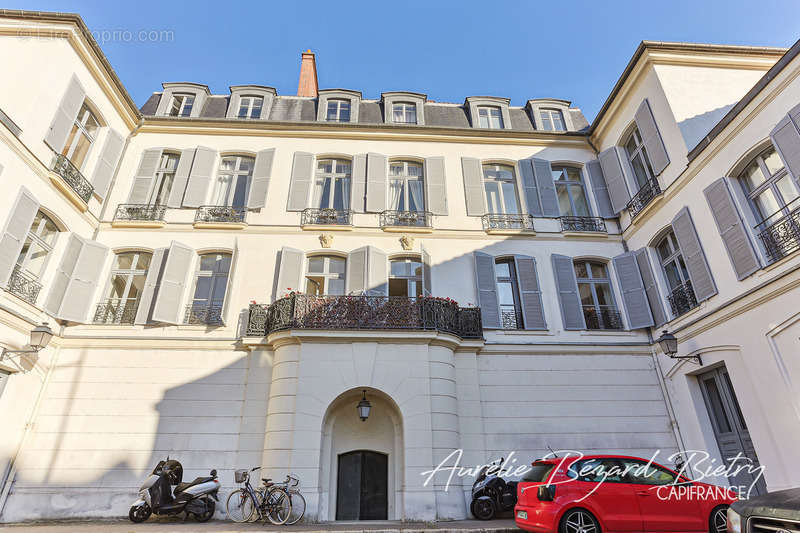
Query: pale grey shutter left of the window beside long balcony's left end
153,241,195,324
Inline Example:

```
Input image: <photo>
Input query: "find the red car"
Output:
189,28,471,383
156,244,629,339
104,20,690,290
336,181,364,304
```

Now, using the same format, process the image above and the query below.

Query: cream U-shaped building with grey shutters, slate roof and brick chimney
0,11,800,522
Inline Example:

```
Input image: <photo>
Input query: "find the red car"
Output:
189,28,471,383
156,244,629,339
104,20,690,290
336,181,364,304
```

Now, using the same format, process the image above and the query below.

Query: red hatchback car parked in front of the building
514,455,736,533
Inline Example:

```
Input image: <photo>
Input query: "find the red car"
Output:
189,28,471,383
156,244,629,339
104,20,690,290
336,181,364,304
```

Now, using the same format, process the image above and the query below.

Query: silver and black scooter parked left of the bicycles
128,457,220,523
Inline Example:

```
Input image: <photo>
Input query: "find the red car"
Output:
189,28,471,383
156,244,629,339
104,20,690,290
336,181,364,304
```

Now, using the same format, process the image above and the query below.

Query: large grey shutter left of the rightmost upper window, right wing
703,178,761,280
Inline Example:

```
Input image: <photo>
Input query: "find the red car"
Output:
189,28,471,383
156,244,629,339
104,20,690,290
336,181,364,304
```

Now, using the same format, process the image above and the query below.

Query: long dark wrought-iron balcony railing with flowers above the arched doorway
247,294,483,339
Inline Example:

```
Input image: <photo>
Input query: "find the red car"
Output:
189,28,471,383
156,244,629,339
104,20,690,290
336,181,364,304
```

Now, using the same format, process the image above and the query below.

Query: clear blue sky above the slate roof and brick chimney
7,0,800,120
